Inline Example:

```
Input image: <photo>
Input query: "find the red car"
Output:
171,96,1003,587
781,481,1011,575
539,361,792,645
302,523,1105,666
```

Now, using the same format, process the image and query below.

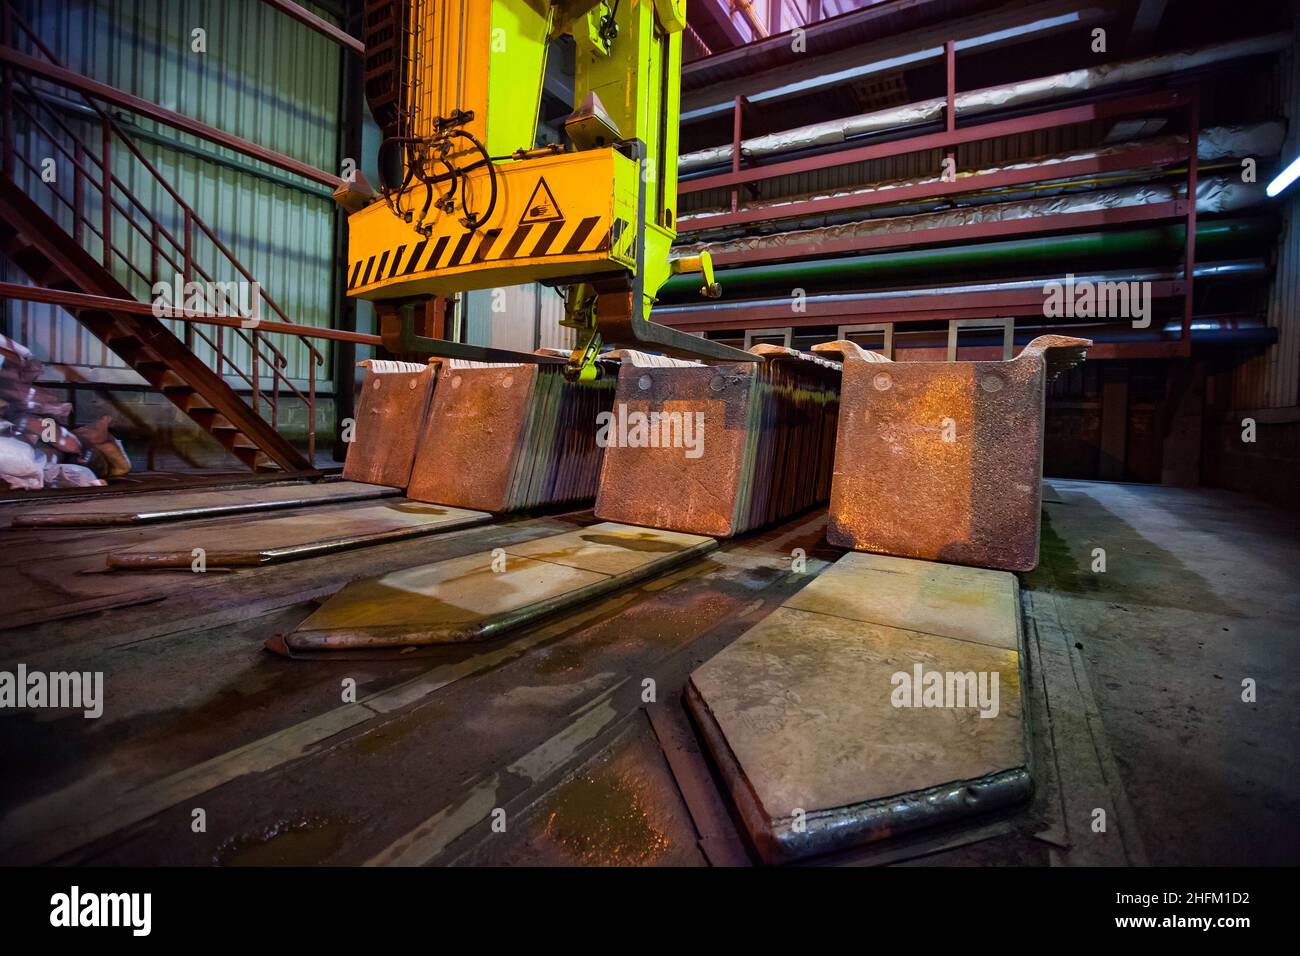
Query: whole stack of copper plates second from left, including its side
407,359,614,512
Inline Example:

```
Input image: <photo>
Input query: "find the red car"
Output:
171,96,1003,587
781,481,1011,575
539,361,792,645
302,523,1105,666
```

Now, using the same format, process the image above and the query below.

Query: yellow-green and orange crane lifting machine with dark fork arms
335,0,755,378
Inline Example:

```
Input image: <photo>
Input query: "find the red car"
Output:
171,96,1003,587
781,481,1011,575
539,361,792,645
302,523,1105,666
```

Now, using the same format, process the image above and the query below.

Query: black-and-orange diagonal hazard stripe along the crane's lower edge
347,216,608,290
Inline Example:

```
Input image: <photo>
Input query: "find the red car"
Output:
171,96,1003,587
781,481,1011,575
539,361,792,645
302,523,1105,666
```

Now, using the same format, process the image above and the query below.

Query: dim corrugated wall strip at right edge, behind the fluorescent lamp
1232,32,1300,410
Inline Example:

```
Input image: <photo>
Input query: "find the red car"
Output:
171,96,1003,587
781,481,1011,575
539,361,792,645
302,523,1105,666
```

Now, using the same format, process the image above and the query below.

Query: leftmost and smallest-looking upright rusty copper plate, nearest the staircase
343,362,434,488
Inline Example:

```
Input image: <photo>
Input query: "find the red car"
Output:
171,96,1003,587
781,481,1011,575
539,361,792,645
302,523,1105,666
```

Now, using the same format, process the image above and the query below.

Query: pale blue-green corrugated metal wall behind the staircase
7,0,342,390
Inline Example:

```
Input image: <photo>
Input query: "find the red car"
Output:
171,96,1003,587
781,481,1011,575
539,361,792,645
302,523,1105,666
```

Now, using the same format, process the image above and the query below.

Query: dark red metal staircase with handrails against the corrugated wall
0,5,325,471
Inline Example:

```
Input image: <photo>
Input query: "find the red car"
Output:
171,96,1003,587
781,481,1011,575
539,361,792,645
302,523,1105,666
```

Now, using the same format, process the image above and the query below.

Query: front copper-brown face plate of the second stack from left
407,362,538,512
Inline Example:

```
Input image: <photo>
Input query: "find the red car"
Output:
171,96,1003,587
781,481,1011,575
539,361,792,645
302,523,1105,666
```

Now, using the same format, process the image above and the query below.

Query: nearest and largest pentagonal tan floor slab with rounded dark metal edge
686,554,1032,864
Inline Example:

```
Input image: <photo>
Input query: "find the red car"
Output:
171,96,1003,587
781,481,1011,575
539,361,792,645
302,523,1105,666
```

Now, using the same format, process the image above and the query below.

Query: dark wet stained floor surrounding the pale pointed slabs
0,481,1300,865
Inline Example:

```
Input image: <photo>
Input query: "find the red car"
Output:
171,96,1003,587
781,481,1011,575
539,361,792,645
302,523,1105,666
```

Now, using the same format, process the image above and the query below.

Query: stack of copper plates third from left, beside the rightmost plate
595,346,840,537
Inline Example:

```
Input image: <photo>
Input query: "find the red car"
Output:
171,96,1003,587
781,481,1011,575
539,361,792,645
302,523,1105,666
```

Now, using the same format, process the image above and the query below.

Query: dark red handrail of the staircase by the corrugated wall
0,4,325,460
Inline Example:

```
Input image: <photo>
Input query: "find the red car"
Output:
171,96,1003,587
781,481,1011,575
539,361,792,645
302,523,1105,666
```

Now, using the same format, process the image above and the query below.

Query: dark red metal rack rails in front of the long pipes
676,40,1200,358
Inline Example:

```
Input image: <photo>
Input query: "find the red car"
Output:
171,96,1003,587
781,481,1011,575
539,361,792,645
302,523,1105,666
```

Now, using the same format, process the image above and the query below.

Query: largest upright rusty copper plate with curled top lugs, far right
815,336,1091,571
